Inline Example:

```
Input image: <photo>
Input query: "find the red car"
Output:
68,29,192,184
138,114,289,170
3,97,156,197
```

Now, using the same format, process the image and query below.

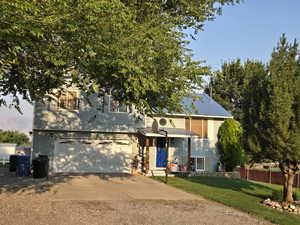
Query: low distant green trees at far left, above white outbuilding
0,130,30,146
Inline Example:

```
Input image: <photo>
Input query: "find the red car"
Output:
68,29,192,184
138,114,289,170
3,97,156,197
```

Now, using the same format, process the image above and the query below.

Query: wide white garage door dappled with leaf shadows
53,139,132,173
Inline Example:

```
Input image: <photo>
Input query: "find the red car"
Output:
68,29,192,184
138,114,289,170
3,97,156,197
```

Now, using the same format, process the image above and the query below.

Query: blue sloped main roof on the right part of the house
166,93,233,118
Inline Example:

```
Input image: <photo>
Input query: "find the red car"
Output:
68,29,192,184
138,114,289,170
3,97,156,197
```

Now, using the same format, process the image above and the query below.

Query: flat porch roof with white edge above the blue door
138,127,198,138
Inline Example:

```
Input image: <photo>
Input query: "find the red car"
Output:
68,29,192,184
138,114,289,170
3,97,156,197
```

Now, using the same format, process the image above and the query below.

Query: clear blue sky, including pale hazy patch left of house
0,0,300,134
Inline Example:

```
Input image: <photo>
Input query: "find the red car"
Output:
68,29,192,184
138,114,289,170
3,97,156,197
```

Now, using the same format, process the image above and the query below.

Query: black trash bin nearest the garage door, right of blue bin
32,155,49,178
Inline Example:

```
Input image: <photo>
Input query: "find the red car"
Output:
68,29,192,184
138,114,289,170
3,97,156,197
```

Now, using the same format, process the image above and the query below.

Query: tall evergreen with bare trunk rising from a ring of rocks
263,35,300,202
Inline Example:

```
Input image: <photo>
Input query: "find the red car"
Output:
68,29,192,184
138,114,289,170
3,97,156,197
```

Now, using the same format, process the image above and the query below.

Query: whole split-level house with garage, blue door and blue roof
33,88,232,174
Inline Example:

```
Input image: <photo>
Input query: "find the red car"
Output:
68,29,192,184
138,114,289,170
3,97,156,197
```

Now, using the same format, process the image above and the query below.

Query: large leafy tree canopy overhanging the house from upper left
0,0,238,112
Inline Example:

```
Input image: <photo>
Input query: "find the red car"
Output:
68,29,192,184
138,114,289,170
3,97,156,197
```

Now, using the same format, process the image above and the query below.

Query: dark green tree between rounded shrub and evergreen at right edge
241,61,268,163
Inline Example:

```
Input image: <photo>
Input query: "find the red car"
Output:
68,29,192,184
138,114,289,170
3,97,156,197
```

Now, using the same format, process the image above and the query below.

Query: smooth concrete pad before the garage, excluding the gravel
51,175,200,201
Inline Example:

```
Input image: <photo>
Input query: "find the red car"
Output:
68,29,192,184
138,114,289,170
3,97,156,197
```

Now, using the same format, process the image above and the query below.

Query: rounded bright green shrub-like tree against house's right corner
218,119,244,171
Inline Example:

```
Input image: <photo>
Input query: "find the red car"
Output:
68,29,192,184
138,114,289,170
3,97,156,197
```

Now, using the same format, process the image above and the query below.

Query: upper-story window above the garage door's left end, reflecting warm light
58,91,79,110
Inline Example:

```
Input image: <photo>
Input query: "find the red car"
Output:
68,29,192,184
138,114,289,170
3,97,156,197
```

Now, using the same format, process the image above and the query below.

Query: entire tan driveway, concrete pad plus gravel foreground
0,171,271,225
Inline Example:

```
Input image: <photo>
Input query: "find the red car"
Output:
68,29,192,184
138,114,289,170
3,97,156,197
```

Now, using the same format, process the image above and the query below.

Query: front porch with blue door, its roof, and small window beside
139,128,205,176
